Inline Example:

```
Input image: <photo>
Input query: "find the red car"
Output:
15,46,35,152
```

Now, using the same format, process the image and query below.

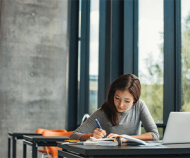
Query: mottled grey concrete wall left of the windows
0,0,68,158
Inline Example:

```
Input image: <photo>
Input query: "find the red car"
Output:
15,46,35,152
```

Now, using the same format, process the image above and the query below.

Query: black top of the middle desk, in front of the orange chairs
23,135,69,142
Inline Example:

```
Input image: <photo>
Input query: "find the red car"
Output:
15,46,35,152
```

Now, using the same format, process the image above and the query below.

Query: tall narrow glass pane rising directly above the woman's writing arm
89,0,99,114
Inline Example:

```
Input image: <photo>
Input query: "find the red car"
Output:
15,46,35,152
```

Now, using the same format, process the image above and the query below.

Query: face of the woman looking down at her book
114,90,134,112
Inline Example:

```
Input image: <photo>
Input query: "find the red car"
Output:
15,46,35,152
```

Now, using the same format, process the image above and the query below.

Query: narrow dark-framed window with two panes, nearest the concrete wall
77,0,99,125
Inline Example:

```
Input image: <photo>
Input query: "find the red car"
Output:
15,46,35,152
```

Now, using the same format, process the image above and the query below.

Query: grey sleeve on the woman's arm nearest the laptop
140,101,159,140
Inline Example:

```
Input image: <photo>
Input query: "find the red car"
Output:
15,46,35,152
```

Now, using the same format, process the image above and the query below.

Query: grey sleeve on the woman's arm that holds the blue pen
70,110,101,140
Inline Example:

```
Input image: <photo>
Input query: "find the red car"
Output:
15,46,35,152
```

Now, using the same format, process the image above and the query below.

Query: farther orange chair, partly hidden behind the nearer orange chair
36,128,67,155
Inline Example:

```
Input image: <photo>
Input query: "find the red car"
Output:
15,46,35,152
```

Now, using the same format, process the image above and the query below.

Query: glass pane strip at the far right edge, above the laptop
181,0,190,111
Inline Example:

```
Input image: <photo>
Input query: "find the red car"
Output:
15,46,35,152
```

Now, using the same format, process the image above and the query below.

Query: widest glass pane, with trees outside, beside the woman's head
139,0,164,123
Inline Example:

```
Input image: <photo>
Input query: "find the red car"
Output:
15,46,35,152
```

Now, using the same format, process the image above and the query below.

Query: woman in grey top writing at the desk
70,74,159,142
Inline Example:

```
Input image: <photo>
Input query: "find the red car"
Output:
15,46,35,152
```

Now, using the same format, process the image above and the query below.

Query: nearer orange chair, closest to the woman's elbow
42,130,73,158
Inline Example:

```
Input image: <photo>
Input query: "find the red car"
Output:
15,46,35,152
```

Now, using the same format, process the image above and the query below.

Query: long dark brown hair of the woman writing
101,74,141,126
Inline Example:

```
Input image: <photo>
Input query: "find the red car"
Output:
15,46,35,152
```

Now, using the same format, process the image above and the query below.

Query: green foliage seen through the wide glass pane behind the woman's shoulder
139,37,164,123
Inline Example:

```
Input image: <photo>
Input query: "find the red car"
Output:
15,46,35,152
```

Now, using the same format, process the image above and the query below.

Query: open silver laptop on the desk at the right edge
162,112,190,144
